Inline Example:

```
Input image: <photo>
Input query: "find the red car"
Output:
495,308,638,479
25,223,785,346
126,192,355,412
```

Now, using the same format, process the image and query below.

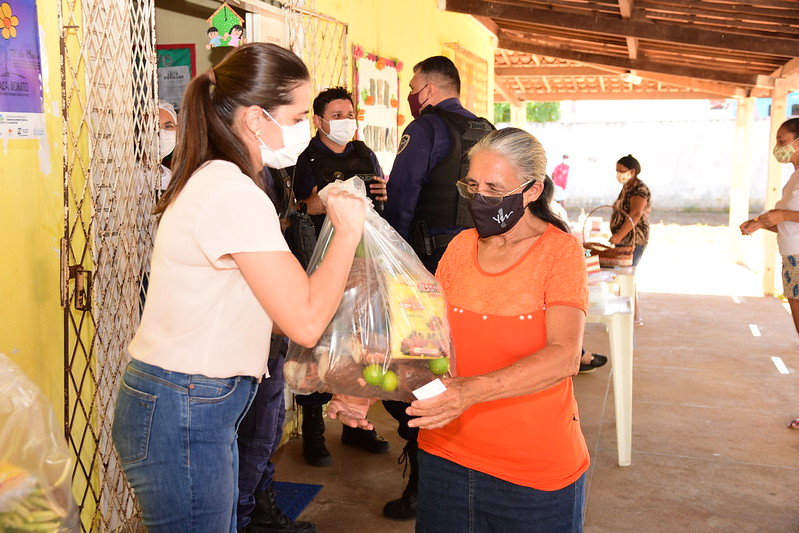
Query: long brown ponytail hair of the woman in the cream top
154,43,311,215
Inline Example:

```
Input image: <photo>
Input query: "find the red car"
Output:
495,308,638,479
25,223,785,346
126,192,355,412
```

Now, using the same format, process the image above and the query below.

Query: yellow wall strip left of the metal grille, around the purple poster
0,1,64,410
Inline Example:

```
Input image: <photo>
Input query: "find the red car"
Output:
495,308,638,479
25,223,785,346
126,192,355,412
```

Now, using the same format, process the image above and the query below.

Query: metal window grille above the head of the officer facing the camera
287,1,352,96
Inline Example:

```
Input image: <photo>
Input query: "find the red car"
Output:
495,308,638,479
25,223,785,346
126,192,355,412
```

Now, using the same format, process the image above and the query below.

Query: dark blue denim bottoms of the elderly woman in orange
416,450,585,533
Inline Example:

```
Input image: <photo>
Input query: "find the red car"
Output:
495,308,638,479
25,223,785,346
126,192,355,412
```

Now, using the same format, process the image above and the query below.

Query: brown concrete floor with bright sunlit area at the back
276,225,799,533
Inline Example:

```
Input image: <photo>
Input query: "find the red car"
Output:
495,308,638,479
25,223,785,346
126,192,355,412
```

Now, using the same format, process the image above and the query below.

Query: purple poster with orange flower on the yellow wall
0,0,44,139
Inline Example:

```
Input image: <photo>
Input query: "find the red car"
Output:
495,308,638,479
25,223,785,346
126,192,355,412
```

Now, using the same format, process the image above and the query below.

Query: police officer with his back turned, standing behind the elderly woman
383,56,494,520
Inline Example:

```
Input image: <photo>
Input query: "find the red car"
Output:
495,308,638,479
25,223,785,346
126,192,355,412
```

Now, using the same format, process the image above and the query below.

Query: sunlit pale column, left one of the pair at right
730,98,755,263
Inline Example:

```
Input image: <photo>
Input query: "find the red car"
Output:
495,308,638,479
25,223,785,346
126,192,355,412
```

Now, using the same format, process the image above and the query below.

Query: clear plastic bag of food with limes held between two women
284,177,455,402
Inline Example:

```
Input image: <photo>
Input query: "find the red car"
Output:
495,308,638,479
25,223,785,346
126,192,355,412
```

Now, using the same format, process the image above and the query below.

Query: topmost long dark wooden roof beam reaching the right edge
440,0,799,57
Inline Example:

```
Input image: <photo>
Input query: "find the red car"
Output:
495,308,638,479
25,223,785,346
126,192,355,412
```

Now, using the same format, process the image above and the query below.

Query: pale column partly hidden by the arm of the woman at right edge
763,78,788,295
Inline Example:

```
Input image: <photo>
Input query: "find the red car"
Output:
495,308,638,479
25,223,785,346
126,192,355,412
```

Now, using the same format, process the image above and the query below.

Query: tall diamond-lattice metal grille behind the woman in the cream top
58,0,160,532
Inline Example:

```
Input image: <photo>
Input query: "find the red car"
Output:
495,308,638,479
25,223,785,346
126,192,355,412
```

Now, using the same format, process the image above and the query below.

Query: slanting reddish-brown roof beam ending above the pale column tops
497,32,772,87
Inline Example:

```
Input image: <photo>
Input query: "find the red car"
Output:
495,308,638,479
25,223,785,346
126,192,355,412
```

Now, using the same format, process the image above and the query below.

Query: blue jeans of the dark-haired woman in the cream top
112,359,257,533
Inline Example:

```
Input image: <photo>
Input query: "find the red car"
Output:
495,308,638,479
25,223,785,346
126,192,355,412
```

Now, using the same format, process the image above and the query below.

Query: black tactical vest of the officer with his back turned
411,106,495,231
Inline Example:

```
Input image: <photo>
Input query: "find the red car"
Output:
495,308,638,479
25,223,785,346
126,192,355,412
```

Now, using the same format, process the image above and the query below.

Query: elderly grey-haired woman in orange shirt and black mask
407,128,589,533
